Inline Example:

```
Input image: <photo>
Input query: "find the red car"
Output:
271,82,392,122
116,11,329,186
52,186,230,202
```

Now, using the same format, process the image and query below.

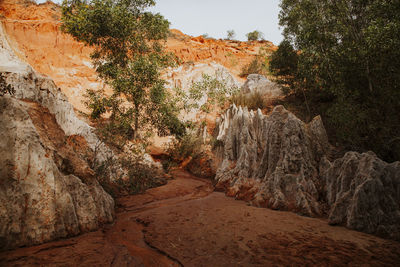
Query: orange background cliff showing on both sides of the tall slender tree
0,0,275,111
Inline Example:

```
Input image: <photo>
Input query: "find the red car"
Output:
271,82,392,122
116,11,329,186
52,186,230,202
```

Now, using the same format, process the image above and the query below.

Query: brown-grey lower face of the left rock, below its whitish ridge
0,96,114,249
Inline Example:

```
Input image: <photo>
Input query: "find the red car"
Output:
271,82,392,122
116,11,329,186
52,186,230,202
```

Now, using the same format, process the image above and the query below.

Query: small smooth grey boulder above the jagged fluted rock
242,74,282,97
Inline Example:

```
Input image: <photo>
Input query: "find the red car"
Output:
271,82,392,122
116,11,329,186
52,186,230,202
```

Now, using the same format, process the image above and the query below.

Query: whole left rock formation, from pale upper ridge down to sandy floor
0,24,114,250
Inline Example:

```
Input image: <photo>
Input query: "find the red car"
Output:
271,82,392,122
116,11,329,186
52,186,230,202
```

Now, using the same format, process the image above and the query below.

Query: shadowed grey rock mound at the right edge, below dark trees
320,152,400,240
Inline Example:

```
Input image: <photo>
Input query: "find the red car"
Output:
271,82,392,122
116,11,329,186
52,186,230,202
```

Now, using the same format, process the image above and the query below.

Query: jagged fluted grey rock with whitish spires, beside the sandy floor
216,106,328,216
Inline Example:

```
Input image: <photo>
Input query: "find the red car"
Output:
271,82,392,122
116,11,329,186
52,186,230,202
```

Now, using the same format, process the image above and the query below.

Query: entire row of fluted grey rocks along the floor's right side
216,106,400,240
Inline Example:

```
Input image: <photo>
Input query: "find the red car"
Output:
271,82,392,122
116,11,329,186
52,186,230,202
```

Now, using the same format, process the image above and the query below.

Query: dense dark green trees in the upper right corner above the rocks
272,0,400,161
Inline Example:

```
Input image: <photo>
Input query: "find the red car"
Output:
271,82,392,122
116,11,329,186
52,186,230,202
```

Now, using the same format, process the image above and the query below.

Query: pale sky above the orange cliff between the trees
37,0,283,45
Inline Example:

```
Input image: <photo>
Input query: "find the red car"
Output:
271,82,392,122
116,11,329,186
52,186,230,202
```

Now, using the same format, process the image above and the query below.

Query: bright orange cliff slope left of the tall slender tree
0,0,102,110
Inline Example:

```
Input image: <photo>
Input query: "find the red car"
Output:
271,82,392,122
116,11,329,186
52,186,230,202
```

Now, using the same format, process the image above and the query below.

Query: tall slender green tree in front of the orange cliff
62,0,182,139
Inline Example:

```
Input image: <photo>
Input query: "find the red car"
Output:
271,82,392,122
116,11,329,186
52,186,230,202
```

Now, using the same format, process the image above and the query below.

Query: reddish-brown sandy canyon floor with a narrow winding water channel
0,171,400,266
